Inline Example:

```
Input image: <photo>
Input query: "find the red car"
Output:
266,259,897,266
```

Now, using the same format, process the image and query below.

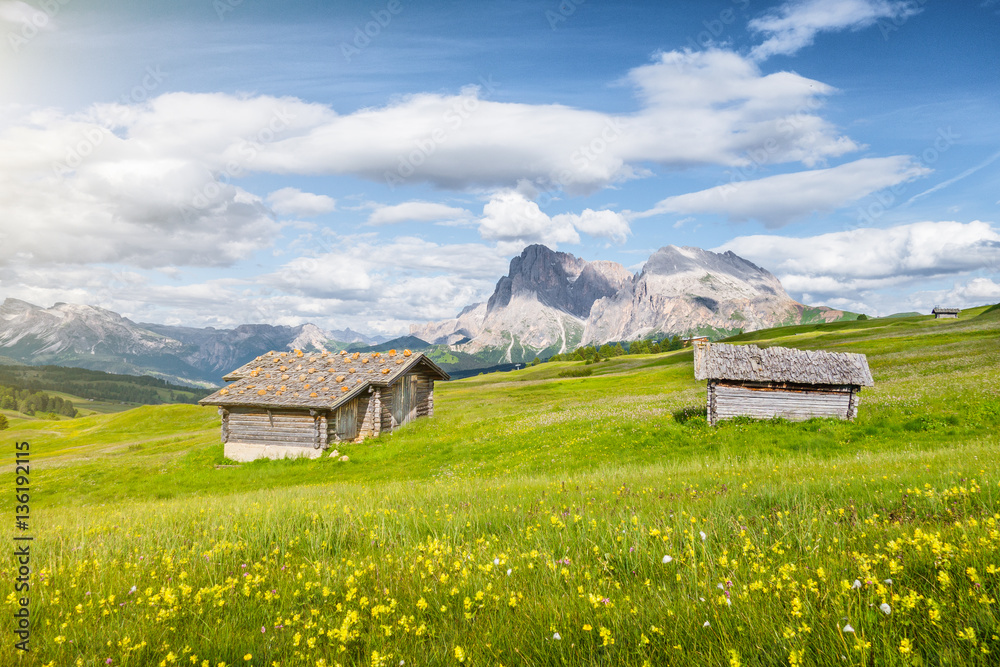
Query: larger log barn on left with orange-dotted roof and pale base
199,350,449,461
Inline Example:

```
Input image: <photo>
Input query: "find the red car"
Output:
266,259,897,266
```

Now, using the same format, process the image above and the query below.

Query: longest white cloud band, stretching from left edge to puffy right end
0,49,858,218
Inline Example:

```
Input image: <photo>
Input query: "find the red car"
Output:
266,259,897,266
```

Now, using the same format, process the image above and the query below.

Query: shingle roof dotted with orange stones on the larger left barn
198,350,449,410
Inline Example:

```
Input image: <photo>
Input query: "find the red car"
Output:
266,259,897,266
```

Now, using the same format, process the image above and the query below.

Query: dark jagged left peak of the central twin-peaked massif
410,245,631,362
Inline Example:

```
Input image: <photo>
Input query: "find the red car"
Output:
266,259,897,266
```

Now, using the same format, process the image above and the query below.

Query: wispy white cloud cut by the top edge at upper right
748,0,920,60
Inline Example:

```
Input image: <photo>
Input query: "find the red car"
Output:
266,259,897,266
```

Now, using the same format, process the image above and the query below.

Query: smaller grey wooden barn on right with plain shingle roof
694,343,875,425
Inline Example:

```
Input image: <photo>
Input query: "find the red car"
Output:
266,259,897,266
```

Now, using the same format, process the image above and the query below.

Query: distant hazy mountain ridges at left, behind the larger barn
0,299,366,384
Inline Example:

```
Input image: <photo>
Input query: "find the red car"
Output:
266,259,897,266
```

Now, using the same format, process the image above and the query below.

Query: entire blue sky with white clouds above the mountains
0,0,1000,333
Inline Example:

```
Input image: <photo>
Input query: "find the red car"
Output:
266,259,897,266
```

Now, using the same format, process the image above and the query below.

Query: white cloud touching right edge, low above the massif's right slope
716,220,1000,298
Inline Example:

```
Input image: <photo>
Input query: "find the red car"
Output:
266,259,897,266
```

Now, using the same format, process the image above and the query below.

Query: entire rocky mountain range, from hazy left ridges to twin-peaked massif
0,245,856,386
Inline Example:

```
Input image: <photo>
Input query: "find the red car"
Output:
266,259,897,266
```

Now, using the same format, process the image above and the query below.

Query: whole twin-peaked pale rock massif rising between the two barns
410,245,844,363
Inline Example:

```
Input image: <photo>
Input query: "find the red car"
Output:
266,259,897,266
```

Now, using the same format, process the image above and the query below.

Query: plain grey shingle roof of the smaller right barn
694,343,875,387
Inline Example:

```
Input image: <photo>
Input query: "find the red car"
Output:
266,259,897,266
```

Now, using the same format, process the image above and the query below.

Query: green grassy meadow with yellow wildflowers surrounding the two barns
0,307,1000,667
